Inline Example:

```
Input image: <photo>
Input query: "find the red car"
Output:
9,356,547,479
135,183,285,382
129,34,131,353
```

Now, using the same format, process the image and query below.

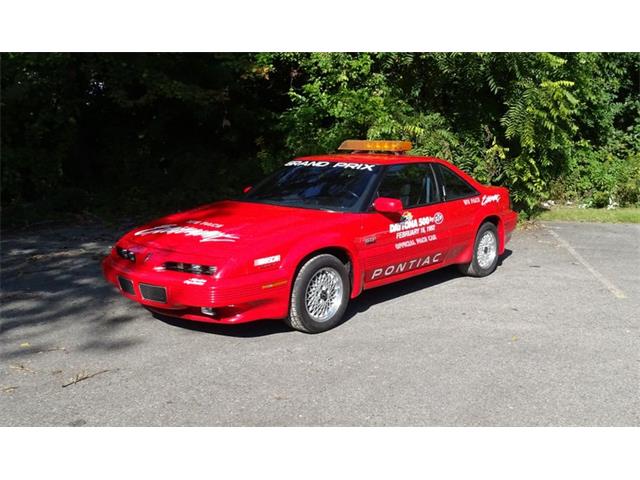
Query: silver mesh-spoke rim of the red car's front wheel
304,267,344,322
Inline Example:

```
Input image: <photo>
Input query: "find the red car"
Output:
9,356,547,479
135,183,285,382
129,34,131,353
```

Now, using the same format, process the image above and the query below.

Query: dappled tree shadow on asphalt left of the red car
0,226,140,360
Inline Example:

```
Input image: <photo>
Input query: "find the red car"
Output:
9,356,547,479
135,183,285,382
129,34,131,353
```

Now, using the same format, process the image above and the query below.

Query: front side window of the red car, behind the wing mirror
378,163,439,208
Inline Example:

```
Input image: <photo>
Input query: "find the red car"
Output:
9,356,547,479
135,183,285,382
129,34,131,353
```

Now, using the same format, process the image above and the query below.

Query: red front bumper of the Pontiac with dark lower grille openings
102,255,290,323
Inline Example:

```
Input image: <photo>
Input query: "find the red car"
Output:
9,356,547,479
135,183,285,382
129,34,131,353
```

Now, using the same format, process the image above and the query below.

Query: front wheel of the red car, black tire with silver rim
285,254,351,333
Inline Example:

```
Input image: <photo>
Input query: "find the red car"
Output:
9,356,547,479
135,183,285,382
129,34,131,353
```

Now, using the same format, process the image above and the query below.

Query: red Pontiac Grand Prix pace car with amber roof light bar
102,140,517,333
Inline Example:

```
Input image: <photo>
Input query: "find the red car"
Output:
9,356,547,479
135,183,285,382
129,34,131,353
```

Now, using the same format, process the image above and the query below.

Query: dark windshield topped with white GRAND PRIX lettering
241,160,381,211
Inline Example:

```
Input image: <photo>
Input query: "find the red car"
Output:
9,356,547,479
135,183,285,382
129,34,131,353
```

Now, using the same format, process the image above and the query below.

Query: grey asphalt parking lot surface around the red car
0,222,640,426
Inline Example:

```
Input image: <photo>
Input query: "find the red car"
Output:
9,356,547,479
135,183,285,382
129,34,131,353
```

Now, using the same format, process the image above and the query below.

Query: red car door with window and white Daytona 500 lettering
359,162,449,284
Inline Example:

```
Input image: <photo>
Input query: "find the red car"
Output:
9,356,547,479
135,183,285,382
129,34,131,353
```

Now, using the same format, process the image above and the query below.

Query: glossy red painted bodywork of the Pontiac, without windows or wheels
102,154,517,323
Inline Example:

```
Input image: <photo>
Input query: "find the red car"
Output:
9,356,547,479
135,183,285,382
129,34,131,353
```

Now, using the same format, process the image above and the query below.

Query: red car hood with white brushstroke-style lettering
125,201,344,256
